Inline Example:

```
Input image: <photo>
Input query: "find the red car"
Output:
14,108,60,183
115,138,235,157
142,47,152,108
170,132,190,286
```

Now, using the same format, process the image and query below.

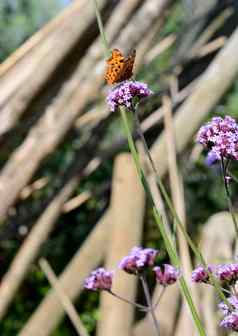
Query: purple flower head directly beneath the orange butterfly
107,81,153,112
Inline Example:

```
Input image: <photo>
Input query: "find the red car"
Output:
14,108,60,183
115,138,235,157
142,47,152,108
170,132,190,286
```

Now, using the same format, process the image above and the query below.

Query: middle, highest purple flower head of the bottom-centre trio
119,247,159,274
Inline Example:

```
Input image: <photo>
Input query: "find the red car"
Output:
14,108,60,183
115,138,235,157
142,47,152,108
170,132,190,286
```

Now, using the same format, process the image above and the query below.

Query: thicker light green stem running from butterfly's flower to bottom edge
120,107,206,336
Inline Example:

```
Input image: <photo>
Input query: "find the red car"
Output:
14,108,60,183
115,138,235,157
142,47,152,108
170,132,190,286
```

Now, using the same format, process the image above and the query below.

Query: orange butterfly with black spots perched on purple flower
104,49,136,85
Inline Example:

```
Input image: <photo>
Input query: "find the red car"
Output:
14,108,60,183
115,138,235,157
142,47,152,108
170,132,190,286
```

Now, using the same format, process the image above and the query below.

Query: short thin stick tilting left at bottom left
39,259,89,336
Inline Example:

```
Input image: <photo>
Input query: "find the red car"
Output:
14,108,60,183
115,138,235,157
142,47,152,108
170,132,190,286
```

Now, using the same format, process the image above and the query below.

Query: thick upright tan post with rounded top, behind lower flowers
97,154,145,336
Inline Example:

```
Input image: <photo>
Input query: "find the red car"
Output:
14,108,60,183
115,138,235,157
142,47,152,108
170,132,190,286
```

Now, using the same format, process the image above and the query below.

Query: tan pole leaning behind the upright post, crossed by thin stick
19,210,112,336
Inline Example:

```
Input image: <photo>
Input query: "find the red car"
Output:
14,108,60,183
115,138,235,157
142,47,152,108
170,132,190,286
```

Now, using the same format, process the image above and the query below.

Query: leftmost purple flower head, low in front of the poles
84,267,114,291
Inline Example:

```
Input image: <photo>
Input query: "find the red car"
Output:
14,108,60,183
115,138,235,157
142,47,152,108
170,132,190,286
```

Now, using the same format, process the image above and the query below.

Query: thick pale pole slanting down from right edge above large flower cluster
151,29,238,175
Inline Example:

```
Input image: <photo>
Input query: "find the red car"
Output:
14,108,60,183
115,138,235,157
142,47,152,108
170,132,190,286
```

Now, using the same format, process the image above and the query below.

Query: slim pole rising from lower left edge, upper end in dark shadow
0,119,110,319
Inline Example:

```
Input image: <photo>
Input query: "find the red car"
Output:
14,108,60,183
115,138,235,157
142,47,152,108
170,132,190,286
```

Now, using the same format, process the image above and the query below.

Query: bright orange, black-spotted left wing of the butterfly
104,49,125,84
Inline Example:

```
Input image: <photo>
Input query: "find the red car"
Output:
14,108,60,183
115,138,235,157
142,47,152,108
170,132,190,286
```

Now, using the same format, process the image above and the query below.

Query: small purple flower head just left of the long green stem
153,264,180,286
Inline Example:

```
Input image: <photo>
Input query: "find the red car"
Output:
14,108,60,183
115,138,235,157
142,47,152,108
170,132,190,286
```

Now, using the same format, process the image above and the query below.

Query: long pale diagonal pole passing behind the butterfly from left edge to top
0,0,169,221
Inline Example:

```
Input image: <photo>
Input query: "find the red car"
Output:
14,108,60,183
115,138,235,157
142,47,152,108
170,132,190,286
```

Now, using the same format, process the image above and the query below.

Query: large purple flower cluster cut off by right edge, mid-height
197,116,238,165
